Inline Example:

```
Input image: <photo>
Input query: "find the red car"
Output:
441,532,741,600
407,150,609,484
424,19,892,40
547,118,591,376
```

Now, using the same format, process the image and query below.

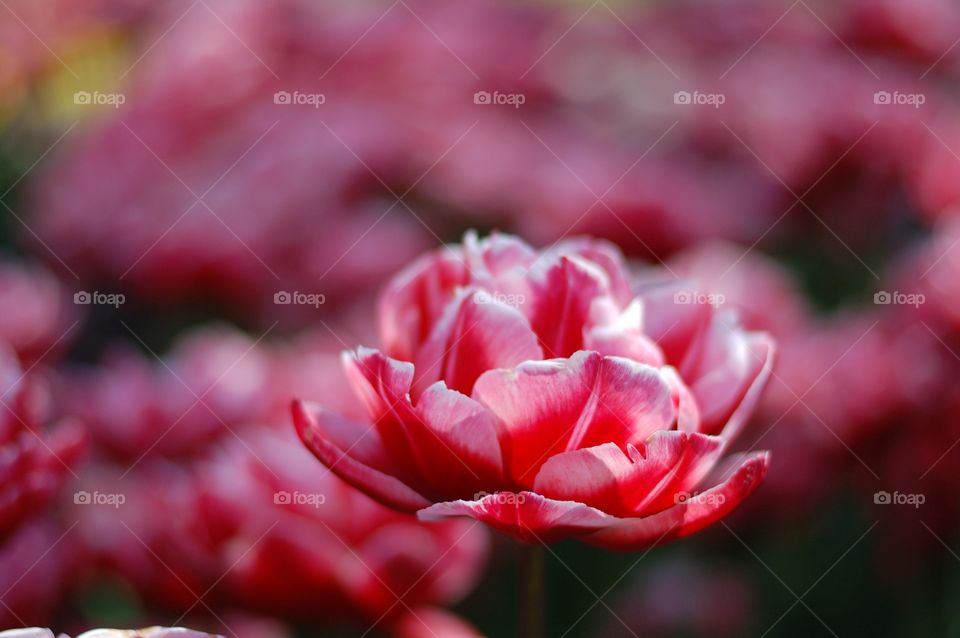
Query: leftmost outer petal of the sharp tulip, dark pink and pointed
293,401,430,512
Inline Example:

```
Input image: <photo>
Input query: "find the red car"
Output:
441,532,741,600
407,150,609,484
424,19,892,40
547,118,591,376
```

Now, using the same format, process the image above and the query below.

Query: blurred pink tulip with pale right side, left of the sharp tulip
61,325,281,461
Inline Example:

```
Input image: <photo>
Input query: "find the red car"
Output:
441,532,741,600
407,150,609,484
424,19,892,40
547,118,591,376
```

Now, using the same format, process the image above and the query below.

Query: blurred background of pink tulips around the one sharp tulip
0,0,960,638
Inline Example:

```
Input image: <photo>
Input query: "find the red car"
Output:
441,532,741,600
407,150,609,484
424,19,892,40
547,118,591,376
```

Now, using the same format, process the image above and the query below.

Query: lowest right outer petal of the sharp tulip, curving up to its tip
580,452,769,551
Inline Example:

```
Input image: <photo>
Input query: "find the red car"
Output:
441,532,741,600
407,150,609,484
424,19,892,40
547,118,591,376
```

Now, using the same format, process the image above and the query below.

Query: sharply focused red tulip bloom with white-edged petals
293,234,773,549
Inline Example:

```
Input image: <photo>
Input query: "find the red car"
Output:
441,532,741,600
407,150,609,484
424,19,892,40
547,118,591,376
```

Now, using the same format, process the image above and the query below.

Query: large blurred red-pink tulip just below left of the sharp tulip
200,431,487,619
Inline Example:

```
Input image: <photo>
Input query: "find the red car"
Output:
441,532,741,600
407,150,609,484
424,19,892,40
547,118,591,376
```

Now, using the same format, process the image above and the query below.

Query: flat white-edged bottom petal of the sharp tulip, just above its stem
417,492,617,544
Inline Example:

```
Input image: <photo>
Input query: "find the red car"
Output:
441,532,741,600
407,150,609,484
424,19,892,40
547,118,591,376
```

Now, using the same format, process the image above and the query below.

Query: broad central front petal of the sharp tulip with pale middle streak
473,352,675,486
